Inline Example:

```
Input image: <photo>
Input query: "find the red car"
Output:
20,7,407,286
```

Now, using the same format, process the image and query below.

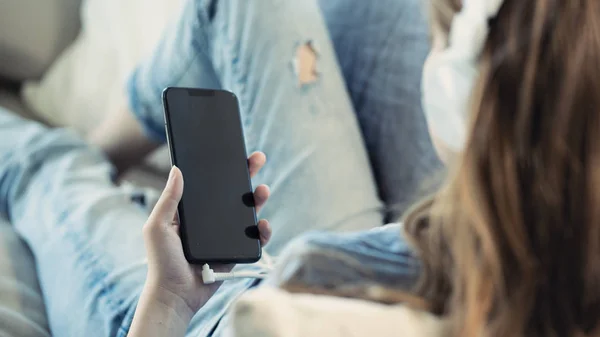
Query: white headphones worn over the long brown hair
422,0,488,162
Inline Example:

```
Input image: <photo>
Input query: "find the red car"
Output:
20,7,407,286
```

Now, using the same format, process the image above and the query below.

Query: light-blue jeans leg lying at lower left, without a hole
0,111,147,336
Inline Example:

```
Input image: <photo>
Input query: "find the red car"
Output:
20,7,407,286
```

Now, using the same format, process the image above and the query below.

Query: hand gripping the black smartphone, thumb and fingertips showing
136,161,271,318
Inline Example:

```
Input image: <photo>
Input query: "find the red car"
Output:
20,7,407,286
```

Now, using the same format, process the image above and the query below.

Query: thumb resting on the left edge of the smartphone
148,166,183,226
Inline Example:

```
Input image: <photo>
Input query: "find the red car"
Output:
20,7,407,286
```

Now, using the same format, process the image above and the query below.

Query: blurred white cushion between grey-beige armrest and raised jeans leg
23,0,181,134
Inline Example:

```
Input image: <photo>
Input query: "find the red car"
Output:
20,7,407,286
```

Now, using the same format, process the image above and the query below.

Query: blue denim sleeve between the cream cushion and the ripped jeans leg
267,224,419,290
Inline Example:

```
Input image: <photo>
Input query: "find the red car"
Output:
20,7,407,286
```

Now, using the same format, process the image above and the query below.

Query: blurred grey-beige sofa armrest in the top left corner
0,0,81,81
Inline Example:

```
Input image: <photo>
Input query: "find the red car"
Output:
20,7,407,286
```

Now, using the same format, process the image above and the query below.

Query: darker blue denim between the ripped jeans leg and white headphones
319,0,443,220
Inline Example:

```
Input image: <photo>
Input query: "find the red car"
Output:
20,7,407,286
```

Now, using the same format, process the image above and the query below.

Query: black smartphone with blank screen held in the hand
163,88,261,264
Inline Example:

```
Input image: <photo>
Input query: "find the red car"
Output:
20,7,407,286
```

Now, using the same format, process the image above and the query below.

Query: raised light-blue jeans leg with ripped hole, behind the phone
130,0,382,254
